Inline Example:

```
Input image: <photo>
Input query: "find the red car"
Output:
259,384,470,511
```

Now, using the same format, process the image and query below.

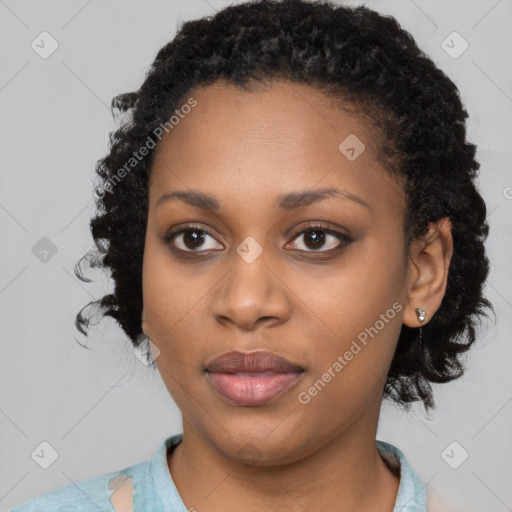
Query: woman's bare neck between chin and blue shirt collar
168,412,399,512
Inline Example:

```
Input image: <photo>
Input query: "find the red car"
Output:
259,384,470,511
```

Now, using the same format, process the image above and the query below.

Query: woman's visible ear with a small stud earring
403,218,453,327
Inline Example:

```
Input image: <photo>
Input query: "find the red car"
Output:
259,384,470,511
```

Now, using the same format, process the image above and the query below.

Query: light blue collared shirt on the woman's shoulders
10,434,427,512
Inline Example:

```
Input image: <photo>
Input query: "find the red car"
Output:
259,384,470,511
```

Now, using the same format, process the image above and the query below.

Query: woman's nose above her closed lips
212,246,291,331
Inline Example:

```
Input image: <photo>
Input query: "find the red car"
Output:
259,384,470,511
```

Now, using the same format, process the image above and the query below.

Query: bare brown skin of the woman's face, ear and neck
142,81,452,512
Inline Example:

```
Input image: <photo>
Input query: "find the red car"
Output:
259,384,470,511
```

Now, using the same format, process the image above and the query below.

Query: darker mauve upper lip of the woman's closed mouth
206,351,303,373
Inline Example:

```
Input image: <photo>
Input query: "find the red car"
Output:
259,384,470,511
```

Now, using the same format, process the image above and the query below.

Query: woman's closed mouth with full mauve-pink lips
205,352,304,406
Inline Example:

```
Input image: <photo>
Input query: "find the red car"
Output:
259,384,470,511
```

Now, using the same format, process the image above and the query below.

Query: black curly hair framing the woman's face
75,0,492,410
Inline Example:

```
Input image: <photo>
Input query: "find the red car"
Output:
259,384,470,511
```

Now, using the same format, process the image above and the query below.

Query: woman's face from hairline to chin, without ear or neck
143,82,409,464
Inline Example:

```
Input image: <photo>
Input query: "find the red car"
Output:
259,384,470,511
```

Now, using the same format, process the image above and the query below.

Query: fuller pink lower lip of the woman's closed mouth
208,372,301,406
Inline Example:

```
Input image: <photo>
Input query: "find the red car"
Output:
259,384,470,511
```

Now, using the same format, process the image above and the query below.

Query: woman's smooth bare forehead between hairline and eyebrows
150,81,403,217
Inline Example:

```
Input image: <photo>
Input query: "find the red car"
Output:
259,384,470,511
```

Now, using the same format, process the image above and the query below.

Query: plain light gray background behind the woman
0,0,512,512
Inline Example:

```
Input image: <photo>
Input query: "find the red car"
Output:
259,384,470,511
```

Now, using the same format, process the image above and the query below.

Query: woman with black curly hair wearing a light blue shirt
11,0,490,512
